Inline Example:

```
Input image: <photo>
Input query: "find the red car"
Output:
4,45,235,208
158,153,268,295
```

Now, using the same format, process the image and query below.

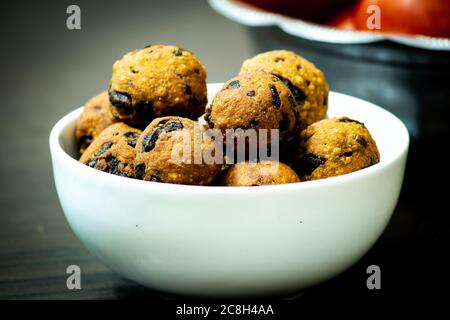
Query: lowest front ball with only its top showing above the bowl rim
221,161,300,186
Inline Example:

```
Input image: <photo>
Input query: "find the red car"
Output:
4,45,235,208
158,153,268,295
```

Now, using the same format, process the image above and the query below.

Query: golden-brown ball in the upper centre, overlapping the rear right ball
205,71,298,148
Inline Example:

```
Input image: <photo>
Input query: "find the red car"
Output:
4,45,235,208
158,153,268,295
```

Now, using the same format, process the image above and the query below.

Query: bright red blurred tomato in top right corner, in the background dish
355,0,450,38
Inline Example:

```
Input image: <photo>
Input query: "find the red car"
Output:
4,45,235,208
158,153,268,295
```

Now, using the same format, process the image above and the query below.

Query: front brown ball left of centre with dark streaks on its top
135,117,223,185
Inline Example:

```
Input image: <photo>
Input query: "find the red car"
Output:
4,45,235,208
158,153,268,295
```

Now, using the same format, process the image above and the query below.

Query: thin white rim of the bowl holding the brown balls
49,87,410,193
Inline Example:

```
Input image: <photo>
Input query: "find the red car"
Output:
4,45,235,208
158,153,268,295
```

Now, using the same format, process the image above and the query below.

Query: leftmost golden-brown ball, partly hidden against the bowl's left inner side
75,91,117,154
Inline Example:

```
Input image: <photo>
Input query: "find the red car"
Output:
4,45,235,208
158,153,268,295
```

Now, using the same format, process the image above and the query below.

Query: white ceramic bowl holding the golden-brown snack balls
50,84,409,297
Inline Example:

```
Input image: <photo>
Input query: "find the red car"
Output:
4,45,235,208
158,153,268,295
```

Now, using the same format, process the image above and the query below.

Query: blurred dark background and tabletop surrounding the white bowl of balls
0,0,450,303
